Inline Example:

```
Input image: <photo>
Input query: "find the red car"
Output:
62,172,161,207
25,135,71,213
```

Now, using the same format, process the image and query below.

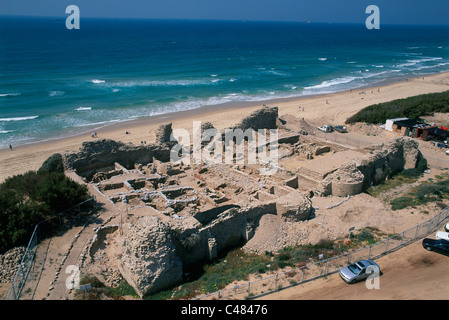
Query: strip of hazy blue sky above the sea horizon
0,0,449,24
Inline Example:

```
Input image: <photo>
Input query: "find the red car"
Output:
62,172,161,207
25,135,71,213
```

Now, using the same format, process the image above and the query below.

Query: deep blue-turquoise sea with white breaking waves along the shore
0,17,449,148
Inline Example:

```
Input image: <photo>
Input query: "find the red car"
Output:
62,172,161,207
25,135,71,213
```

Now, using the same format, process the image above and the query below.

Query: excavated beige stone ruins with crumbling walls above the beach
64,106,421,296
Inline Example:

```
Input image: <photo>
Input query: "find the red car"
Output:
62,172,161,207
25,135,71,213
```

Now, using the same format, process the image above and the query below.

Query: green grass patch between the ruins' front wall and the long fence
145,227,386,300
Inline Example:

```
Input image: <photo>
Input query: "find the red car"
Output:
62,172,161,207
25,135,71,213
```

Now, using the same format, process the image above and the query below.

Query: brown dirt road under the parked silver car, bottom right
260,240,449,300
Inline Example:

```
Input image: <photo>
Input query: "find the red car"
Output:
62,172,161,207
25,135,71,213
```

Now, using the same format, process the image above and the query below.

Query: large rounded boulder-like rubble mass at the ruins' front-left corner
121,217,182,296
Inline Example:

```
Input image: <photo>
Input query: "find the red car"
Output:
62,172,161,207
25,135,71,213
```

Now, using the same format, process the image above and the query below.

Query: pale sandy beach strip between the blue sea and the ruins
0,73,449,181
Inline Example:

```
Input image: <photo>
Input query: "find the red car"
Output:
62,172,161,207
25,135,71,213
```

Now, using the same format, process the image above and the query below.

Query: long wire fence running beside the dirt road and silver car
196,207,449,300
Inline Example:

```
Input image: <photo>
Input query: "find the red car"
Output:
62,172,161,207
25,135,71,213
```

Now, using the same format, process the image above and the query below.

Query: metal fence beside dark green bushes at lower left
5,197,95,300
